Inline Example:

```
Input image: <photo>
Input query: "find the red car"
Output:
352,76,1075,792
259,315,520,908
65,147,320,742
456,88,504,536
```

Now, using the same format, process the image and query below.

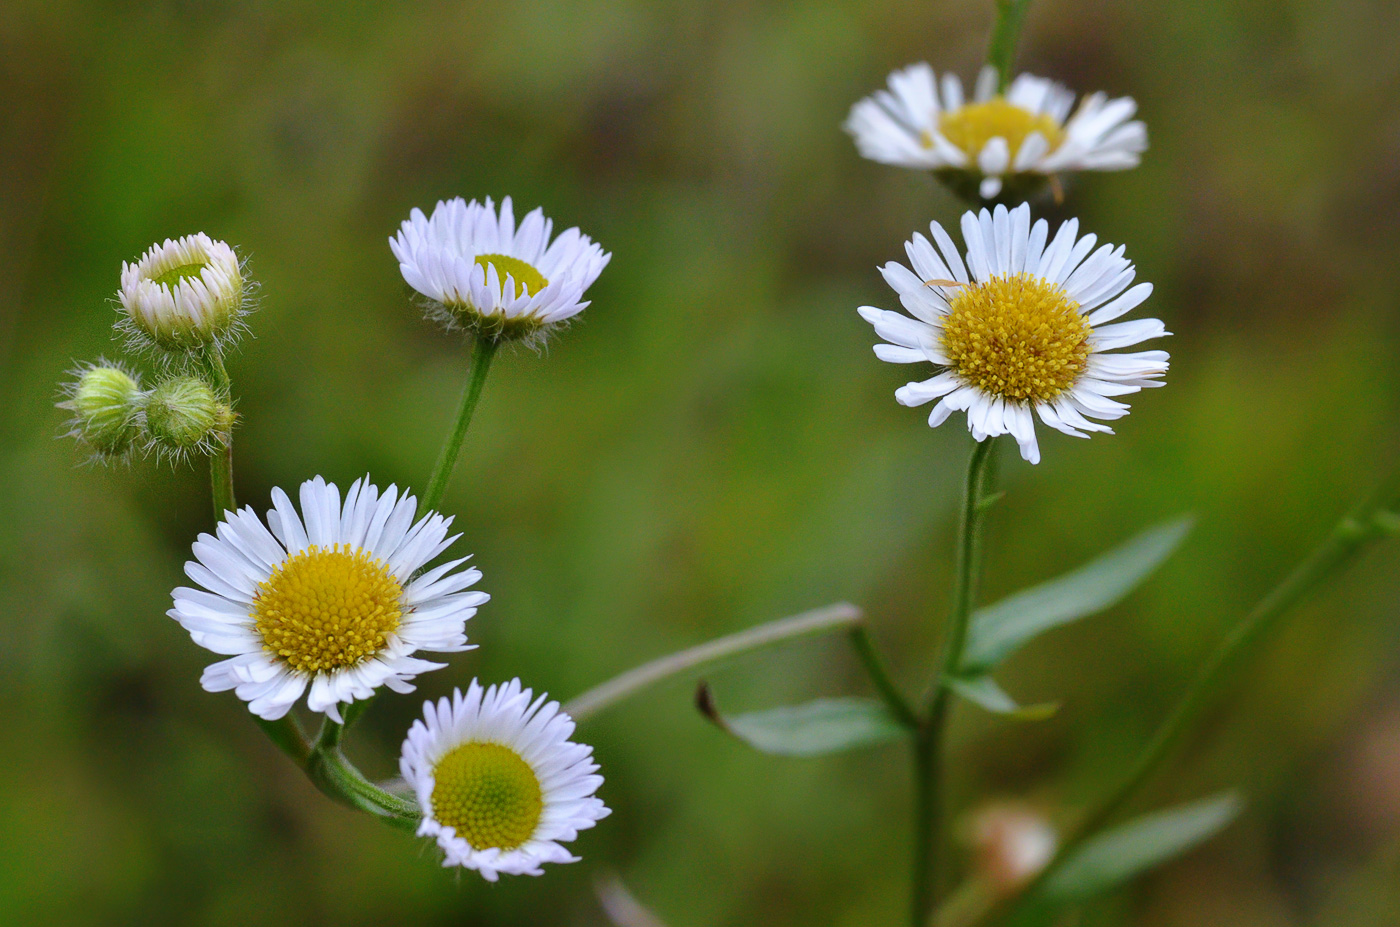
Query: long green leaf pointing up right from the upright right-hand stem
959,518,1191,675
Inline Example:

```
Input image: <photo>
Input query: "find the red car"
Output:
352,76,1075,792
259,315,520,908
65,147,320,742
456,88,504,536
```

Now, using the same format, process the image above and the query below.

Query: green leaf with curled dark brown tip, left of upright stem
696,682,910,756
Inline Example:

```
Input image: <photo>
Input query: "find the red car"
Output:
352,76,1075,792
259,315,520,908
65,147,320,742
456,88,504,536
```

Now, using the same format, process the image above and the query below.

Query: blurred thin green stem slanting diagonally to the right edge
990,472,1400,921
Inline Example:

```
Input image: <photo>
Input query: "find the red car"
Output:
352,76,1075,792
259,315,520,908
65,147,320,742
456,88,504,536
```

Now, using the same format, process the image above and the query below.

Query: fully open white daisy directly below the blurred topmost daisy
860,203,1169,464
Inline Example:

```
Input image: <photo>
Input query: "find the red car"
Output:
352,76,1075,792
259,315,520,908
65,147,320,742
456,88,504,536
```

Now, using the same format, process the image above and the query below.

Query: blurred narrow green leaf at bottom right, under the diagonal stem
1037,793,1243,903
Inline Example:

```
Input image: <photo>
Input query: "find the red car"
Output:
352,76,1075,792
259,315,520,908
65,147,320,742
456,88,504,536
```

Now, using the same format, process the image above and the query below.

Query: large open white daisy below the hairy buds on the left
168,476,490,721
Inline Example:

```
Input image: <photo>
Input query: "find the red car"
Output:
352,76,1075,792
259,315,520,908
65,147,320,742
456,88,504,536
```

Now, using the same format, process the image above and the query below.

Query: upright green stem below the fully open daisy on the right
910,438,997,927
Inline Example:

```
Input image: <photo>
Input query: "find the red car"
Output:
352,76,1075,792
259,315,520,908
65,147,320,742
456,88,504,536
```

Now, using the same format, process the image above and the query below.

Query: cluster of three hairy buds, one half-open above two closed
59,232,253,461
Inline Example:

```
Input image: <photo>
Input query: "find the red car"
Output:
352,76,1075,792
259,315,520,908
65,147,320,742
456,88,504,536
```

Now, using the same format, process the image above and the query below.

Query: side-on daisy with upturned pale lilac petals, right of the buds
389,196,612,339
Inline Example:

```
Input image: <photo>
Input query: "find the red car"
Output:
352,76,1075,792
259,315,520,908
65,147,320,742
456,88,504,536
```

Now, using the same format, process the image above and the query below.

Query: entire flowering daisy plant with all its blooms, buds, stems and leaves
51,0,1400,927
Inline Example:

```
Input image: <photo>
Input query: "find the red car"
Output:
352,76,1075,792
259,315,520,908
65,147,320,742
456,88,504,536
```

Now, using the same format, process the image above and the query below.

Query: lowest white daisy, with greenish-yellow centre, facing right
399,679,612,882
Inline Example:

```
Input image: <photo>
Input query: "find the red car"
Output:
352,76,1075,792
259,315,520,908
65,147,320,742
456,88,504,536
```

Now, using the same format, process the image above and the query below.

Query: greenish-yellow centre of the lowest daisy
433,744,545,850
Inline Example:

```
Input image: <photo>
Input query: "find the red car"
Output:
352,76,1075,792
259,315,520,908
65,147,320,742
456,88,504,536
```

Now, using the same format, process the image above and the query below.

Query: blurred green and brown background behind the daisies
0,0,1400,927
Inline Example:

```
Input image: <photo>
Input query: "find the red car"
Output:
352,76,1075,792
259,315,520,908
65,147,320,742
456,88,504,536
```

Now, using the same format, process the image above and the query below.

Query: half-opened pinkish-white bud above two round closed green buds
116,232,249,351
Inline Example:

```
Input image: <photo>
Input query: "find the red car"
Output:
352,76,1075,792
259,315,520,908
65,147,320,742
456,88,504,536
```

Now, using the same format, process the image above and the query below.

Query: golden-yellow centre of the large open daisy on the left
253,545,403,674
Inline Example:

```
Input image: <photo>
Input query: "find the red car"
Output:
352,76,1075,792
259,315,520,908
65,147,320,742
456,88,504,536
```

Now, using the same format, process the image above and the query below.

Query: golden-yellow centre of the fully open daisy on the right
942,273,1092,403
